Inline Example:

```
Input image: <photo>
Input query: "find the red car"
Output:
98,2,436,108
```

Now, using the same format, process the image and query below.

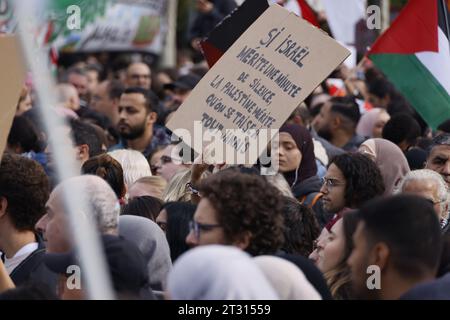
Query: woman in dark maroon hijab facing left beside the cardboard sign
278,124,332,228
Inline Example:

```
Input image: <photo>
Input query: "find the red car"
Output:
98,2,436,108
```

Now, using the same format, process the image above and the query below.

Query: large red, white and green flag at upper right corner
368,0,450,129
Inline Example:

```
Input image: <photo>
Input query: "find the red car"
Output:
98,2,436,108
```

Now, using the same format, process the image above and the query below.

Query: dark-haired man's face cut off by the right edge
425,133,450,187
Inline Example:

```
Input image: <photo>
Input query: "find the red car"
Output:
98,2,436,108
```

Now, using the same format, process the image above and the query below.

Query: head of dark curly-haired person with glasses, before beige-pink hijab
320,153,384,213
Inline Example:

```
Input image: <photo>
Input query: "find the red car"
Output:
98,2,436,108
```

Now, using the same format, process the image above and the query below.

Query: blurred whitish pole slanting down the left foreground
14,0,115,300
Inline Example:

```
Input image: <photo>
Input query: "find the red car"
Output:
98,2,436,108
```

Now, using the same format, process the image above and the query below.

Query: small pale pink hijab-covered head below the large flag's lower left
356,108,391,138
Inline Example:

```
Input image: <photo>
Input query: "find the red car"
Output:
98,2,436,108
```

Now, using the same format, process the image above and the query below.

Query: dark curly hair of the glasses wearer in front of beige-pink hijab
328,153,384,208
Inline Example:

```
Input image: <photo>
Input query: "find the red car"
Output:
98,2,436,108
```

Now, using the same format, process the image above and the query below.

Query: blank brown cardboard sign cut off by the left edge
0,36,25,159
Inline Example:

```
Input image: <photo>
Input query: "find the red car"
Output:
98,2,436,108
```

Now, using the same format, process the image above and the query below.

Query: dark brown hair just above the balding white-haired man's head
81,154,125,199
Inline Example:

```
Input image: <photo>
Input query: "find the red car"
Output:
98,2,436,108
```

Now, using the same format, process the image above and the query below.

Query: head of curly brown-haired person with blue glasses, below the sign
186,168,283,256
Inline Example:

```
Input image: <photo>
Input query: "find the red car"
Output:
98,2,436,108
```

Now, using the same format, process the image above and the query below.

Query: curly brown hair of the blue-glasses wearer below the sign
199,168,283,256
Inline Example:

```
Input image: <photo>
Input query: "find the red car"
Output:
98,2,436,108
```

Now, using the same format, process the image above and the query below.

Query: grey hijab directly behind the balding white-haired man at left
119,215,172,291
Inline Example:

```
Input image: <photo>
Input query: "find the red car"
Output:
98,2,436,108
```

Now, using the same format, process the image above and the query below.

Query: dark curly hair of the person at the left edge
0,153,50,231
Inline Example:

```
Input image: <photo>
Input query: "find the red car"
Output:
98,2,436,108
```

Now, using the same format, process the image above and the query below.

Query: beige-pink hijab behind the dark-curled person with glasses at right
359,138,410,196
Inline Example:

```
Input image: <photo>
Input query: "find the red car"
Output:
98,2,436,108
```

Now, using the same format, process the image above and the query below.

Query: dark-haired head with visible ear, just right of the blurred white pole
70,119,103,165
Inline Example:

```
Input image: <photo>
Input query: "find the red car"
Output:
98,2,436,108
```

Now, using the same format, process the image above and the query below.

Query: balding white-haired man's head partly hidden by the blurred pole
36,175,120,252
